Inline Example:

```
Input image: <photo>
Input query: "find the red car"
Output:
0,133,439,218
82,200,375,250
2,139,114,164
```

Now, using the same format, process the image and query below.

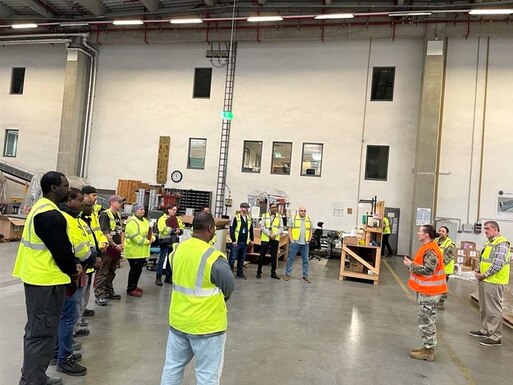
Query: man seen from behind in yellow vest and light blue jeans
161,212,235,385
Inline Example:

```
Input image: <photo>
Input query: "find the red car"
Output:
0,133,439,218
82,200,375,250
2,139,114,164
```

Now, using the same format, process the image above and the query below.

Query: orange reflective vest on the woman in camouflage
408,241,447,295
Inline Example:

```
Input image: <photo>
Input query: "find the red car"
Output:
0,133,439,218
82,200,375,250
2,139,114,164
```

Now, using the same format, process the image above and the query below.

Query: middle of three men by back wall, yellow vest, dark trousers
257,203,283,279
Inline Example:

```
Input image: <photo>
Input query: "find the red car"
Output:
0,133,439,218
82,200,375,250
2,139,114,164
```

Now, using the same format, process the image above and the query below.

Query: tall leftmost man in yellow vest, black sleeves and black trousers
13,171,80,385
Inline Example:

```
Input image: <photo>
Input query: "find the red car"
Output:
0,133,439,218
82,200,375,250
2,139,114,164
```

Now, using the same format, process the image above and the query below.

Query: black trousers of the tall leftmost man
20,283,66,385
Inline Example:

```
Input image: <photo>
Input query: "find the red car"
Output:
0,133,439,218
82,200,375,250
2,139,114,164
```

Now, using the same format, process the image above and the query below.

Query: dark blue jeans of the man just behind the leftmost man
54,287,83,364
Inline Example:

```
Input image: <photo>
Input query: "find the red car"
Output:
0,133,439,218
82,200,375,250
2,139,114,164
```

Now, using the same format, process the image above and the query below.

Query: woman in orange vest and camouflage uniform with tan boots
404,225,447,361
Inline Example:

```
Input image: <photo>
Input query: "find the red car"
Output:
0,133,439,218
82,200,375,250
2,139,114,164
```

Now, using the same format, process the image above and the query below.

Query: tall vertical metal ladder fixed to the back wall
215,42,237,217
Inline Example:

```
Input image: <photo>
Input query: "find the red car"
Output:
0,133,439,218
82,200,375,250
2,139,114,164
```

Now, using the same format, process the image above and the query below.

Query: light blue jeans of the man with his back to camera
160,330,226,385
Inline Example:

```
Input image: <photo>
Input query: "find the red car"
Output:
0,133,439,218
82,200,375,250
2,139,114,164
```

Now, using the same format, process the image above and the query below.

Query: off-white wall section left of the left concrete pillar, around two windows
0,45,66,171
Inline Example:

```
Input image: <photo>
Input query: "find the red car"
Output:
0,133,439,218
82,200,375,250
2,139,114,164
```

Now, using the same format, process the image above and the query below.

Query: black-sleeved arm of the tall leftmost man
34,210,80,276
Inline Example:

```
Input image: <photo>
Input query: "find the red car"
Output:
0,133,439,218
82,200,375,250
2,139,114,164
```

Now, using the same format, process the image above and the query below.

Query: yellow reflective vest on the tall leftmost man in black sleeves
12,198,71,286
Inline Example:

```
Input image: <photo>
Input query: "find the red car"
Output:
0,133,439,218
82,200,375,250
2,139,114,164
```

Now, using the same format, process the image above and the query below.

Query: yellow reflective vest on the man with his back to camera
169,237,228,334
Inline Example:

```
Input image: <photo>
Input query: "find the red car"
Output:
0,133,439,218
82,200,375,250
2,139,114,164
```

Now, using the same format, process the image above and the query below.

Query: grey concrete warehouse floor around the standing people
0,243,513,385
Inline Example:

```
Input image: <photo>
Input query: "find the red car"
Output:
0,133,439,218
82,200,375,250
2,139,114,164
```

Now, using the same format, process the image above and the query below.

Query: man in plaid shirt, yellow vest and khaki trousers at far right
469,221,511,346
